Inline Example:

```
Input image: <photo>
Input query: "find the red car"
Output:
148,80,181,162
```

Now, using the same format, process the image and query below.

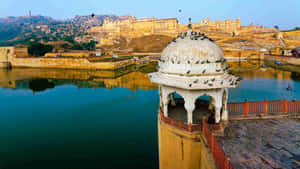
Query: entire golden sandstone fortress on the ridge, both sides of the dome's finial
89,16,277,46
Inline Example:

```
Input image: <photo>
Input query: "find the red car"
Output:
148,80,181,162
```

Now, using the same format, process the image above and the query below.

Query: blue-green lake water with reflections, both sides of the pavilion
0,63,300,169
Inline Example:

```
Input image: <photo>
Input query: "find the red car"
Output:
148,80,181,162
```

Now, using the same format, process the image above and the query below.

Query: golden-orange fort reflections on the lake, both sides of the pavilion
0,61,300,91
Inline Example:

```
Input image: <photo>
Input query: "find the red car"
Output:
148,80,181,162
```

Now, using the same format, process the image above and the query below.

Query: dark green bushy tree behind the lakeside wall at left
28,43,53,57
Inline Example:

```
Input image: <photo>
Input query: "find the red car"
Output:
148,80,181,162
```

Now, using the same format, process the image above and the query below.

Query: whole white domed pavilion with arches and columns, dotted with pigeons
149,30,241,124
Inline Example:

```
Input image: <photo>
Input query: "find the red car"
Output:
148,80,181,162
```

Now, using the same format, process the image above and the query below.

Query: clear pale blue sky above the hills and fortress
0,0,300,29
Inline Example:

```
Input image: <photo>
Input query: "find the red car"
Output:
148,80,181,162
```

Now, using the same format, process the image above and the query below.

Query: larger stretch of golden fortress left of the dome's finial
89,17,185,45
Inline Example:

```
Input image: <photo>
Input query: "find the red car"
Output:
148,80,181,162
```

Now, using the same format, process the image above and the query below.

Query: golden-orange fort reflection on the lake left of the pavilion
0,64,157,91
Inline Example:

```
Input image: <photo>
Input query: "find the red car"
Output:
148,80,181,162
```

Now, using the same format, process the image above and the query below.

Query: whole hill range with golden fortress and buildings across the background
0,13,300,55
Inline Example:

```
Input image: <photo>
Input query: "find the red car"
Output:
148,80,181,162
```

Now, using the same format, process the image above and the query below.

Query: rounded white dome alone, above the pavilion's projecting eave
159,31,226,75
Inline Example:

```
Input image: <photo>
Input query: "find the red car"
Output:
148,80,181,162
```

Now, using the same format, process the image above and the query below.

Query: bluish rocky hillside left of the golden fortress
0,15,129,46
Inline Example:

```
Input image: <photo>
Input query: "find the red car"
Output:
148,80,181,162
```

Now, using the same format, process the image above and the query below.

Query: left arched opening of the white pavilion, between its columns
168,92,187,123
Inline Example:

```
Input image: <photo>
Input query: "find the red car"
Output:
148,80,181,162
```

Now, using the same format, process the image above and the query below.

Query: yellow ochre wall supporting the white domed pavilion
158,115,216,169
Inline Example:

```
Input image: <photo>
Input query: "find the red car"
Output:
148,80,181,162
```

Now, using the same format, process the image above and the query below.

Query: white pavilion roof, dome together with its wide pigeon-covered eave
149,31,241,90
